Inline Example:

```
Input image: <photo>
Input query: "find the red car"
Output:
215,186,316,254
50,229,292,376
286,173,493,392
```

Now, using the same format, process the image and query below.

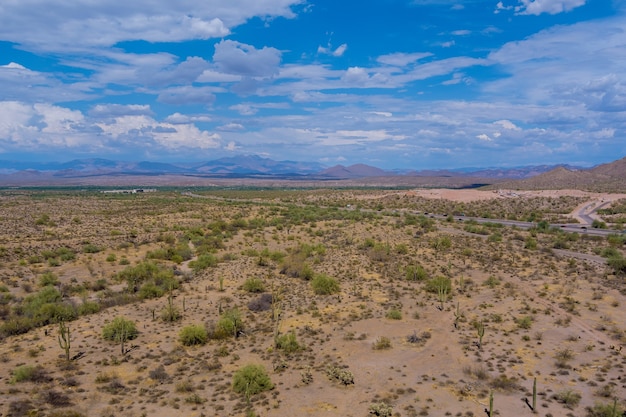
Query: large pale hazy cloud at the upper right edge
484,15,626,112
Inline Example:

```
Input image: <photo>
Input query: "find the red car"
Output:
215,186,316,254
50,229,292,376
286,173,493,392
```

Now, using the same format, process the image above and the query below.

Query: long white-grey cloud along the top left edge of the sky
0,0,301,50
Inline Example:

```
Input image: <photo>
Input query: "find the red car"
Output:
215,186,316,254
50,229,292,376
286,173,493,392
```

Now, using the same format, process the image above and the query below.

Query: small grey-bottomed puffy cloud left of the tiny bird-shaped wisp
213,40,281,77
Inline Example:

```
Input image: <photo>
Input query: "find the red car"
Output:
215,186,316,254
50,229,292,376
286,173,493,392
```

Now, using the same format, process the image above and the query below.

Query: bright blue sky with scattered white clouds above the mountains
0,0,626,169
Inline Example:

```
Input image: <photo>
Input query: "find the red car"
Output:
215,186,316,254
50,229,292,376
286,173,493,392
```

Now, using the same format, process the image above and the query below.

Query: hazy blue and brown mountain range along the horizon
0,155,626,190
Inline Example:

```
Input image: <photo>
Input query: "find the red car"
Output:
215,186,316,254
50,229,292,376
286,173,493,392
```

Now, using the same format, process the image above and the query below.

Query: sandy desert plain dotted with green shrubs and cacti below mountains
0,186,626,417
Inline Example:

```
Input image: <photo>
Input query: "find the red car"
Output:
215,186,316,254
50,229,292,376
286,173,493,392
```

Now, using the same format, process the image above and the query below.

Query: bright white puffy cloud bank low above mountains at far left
0,101,221,156
